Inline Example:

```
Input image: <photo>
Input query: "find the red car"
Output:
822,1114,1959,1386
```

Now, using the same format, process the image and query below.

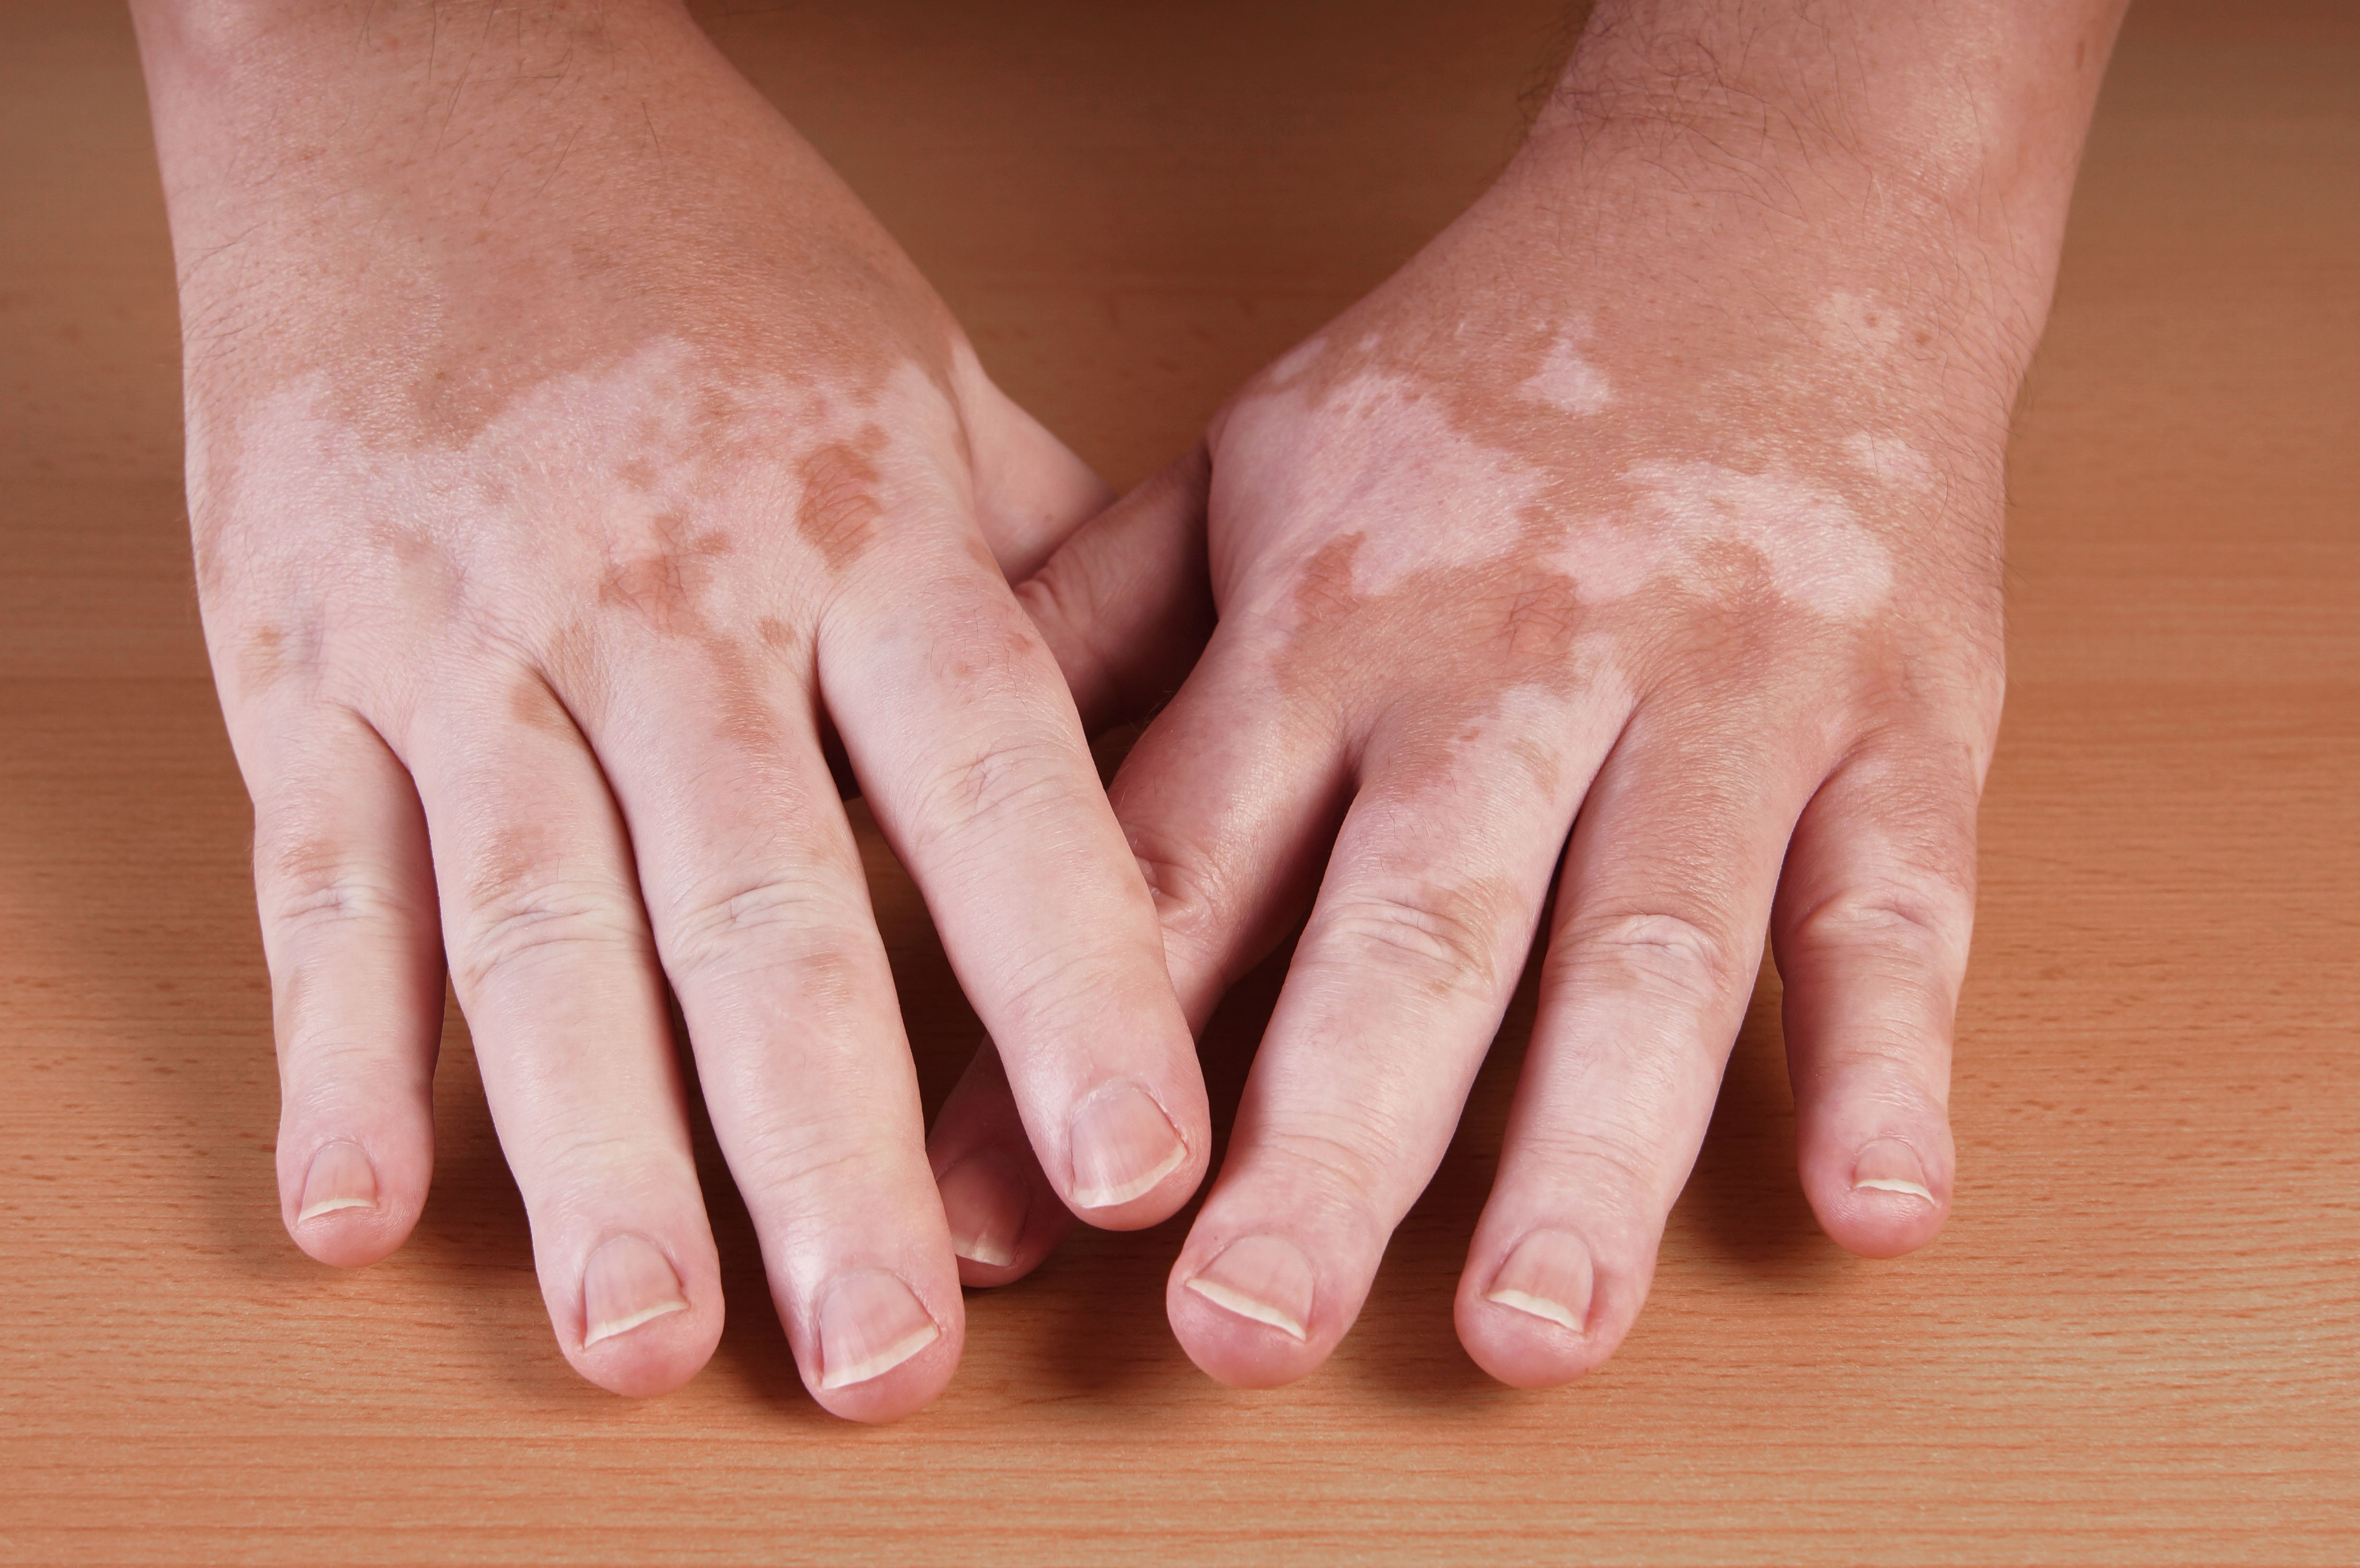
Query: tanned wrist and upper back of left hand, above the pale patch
135,0,939,434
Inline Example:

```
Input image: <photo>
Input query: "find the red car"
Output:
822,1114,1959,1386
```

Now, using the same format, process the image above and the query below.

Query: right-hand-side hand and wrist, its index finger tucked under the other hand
930,5,2112,1386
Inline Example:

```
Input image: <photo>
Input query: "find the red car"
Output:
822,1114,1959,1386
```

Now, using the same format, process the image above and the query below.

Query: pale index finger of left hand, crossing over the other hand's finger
819,538,1208,1228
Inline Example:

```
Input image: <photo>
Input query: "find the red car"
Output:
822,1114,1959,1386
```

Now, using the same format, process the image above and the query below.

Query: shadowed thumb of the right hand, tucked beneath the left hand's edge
1017,441,1213,735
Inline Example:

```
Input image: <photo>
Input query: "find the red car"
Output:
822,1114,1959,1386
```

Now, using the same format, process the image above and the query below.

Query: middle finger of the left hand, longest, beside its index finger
595,640,965,1421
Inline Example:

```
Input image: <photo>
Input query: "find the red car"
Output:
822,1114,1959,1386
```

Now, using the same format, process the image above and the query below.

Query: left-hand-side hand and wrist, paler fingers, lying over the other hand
139,0,1206,1419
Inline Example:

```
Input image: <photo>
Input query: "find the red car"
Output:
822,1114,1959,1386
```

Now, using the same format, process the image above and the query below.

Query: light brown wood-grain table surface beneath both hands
0,0,2360,1568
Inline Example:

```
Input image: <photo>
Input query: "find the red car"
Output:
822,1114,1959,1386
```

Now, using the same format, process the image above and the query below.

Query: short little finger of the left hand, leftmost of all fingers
255,709,443,1266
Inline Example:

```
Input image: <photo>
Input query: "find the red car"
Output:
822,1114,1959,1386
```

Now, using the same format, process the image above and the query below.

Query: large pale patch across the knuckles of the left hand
194,340,951,666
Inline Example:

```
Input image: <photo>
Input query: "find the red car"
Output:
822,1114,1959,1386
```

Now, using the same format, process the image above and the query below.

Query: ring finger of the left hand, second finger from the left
408,673,722,1393
